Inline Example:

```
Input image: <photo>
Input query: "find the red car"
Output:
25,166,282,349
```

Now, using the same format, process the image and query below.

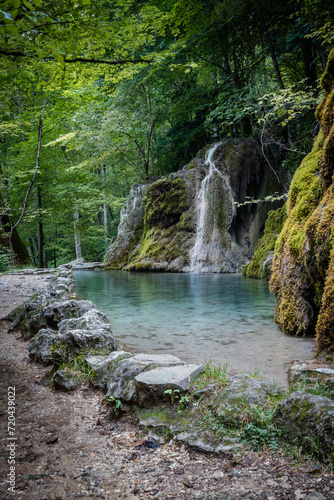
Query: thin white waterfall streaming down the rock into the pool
190,143,236,273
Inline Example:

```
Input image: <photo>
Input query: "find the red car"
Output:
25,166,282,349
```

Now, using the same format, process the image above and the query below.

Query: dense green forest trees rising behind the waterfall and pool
0,0,334,268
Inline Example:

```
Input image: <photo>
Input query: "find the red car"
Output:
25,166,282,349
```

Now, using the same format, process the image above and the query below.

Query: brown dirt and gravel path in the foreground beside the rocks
0,275,334,500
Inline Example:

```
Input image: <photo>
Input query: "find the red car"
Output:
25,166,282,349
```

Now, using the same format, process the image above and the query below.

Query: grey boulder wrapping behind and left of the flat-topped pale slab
107,354,185,403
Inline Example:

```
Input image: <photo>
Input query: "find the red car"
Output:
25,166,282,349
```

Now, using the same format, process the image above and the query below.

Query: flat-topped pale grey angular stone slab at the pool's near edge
135,364,204,403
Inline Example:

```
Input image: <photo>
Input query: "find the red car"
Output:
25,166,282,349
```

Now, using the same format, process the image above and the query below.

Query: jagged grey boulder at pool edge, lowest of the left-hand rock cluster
28,328,117,365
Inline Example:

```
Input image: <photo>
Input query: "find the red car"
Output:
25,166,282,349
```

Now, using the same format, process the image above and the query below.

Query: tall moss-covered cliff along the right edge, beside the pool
270,49,334,351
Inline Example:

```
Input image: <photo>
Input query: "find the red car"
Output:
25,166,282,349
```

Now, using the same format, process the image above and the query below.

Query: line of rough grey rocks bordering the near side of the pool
4,262,334,462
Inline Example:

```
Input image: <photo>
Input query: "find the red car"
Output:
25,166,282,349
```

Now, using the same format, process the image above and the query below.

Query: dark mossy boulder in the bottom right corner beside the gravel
274,391,334,462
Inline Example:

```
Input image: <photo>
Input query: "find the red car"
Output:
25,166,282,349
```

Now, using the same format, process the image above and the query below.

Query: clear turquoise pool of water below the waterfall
73,271,314,386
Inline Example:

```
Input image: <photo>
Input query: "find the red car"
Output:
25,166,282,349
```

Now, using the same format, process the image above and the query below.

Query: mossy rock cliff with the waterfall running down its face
105,139,282,272
